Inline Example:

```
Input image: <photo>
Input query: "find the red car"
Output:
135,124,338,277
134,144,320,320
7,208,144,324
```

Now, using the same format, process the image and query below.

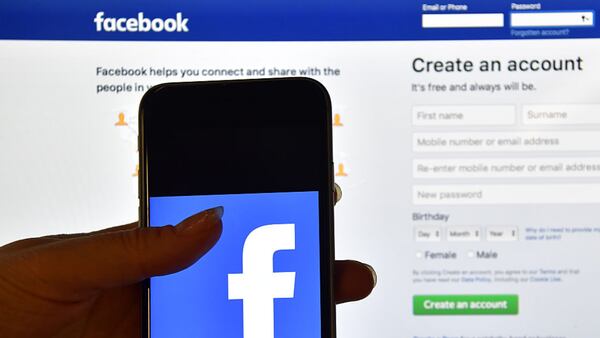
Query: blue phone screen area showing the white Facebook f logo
150,192,321,338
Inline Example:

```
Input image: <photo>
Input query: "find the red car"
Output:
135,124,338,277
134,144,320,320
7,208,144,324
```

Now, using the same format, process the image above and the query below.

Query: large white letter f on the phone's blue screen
228,224,296,338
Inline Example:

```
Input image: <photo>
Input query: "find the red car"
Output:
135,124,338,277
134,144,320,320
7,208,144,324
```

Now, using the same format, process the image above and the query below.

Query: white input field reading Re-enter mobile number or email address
413,157,600,179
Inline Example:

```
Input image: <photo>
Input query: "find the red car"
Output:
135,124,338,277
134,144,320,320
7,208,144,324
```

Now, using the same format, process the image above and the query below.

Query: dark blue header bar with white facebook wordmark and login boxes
0,0,600,41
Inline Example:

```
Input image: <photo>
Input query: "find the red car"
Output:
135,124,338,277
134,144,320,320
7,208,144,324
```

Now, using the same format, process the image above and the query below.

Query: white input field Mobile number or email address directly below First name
413,131,600,152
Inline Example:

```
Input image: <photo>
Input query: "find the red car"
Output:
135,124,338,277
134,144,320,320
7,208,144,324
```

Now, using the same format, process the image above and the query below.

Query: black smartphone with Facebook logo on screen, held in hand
139,78,335,338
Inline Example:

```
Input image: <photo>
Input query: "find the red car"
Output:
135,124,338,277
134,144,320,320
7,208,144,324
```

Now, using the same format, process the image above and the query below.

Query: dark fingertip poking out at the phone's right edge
333,261,377,304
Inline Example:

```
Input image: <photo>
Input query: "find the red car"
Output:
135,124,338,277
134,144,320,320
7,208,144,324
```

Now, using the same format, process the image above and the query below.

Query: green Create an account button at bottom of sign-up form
413,295,519,316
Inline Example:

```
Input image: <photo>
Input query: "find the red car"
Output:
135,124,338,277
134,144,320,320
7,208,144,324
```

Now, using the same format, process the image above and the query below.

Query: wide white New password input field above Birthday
413,183,600,205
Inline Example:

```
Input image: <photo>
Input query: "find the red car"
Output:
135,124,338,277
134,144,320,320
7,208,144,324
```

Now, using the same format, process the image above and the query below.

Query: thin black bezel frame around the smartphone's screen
138,78,336,338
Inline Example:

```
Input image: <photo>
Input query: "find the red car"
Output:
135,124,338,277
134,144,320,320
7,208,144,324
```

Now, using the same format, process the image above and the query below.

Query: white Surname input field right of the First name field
523,104,600,125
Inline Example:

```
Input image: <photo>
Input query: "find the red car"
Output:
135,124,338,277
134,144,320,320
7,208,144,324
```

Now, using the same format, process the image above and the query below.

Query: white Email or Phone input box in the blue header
422,13,504,28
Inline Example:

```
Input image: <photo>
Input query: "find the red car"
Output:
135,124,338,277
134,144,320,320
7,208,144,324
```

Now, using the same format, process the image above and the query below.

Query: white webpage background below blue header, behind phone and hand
0,40,600,338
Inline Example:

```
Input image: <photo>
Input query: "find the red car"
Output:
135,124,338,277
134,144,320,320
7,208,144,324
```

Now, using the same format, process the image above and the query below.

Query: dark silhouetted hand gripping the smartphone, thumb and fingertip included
0,195,375,338
